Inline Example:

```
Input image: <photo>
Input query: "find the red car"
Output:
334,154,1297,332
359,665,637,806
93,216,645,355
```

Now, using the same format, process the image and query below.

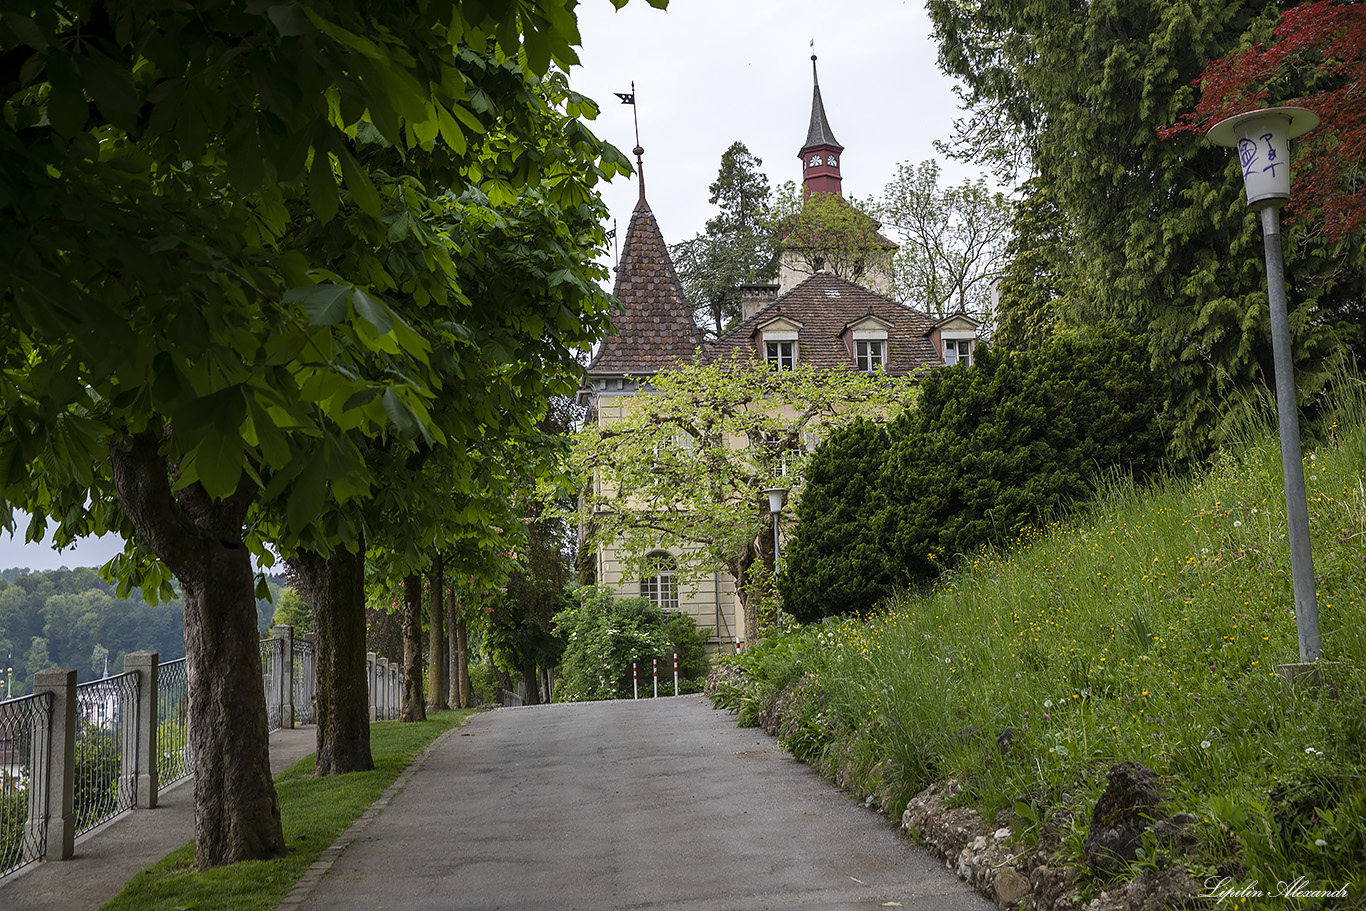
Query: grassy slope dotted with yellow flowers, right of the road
723,387,1366,896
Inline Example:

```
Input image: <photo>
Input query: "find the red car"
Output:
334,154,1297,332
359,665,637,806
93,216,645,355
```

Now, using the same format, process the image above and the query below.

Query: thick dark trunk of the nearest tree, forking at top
109,430,285,870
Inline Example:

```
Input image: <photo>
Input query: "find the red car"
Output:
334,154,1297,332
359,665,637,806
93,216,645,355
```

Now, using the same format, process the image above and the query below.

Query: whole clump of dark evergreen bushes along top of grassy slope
779,331,1167,623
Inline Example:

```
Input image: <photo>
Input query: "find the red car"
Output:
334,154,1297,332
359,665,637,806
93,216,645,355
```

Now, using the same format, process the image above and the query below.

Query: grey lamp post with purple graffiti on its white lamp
1208,108,1321,664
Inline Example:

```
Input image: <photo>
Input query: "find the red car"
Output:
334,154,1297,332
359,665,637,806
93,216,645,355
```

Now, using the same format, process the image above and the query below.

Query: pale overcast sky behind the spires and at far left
0,0,978,570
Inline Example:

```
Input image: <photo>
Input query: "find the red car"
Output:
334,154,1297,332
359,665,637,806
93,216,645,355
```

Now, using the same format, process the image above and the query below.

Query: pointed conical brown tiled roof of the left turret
589,191,702,374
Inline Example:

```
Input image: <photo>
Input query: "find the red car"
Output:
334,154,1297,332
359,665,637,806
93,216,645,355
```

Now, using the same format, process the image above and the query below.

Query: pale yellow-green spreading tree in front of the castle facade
560,358,914,638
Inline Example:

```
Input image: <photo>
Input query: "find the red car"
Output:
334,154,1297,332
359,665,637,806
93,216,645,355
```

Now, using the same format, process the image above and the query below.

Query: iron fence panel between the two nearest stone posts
72,673,138,835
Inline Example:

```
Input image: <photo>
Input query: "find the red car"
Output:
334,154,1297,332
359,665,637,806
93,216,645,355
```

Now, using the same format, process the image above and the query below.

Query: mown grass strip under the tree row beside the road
102,710,470,911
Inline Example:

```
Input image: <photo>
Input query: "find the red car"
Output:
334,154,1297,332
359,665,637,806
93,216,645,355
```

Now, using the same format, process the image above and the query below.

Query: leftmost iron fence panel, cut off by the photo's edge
0,692,52,877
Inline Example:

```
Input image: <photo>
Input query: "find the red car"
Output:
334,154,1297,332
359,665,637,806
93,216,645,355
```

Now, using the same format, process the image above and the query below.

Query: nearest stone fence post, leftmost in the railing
29,668,76,860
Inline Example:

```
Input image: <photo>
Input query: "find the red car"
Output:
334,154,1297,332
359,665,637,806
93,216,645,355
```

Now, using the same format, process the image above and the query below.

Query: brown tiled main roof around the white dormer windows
706,272,944,374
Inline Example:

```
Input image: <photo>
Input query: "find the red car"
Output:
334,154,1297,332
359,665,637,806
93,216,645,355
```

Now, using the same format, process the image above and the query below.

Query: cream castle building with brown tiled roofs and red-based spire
579,56,979,650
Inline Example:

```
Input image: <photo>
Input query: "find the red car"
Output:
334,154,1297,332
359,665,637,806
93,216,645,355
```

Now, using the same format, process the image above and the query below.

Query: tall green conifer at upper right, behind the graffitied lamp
930,0,1341,456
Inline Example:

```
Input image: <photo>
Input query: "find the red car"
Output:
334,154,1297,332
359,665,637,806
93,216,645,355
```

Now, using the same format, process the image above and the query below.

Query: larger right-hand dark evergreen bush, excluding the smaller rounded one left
877,331,1167,582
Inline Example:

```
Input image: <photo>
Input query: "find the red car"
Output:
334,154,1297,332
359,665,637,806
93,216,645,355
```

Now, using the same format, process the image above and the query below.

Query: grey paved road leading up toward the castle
302,697,993,911
